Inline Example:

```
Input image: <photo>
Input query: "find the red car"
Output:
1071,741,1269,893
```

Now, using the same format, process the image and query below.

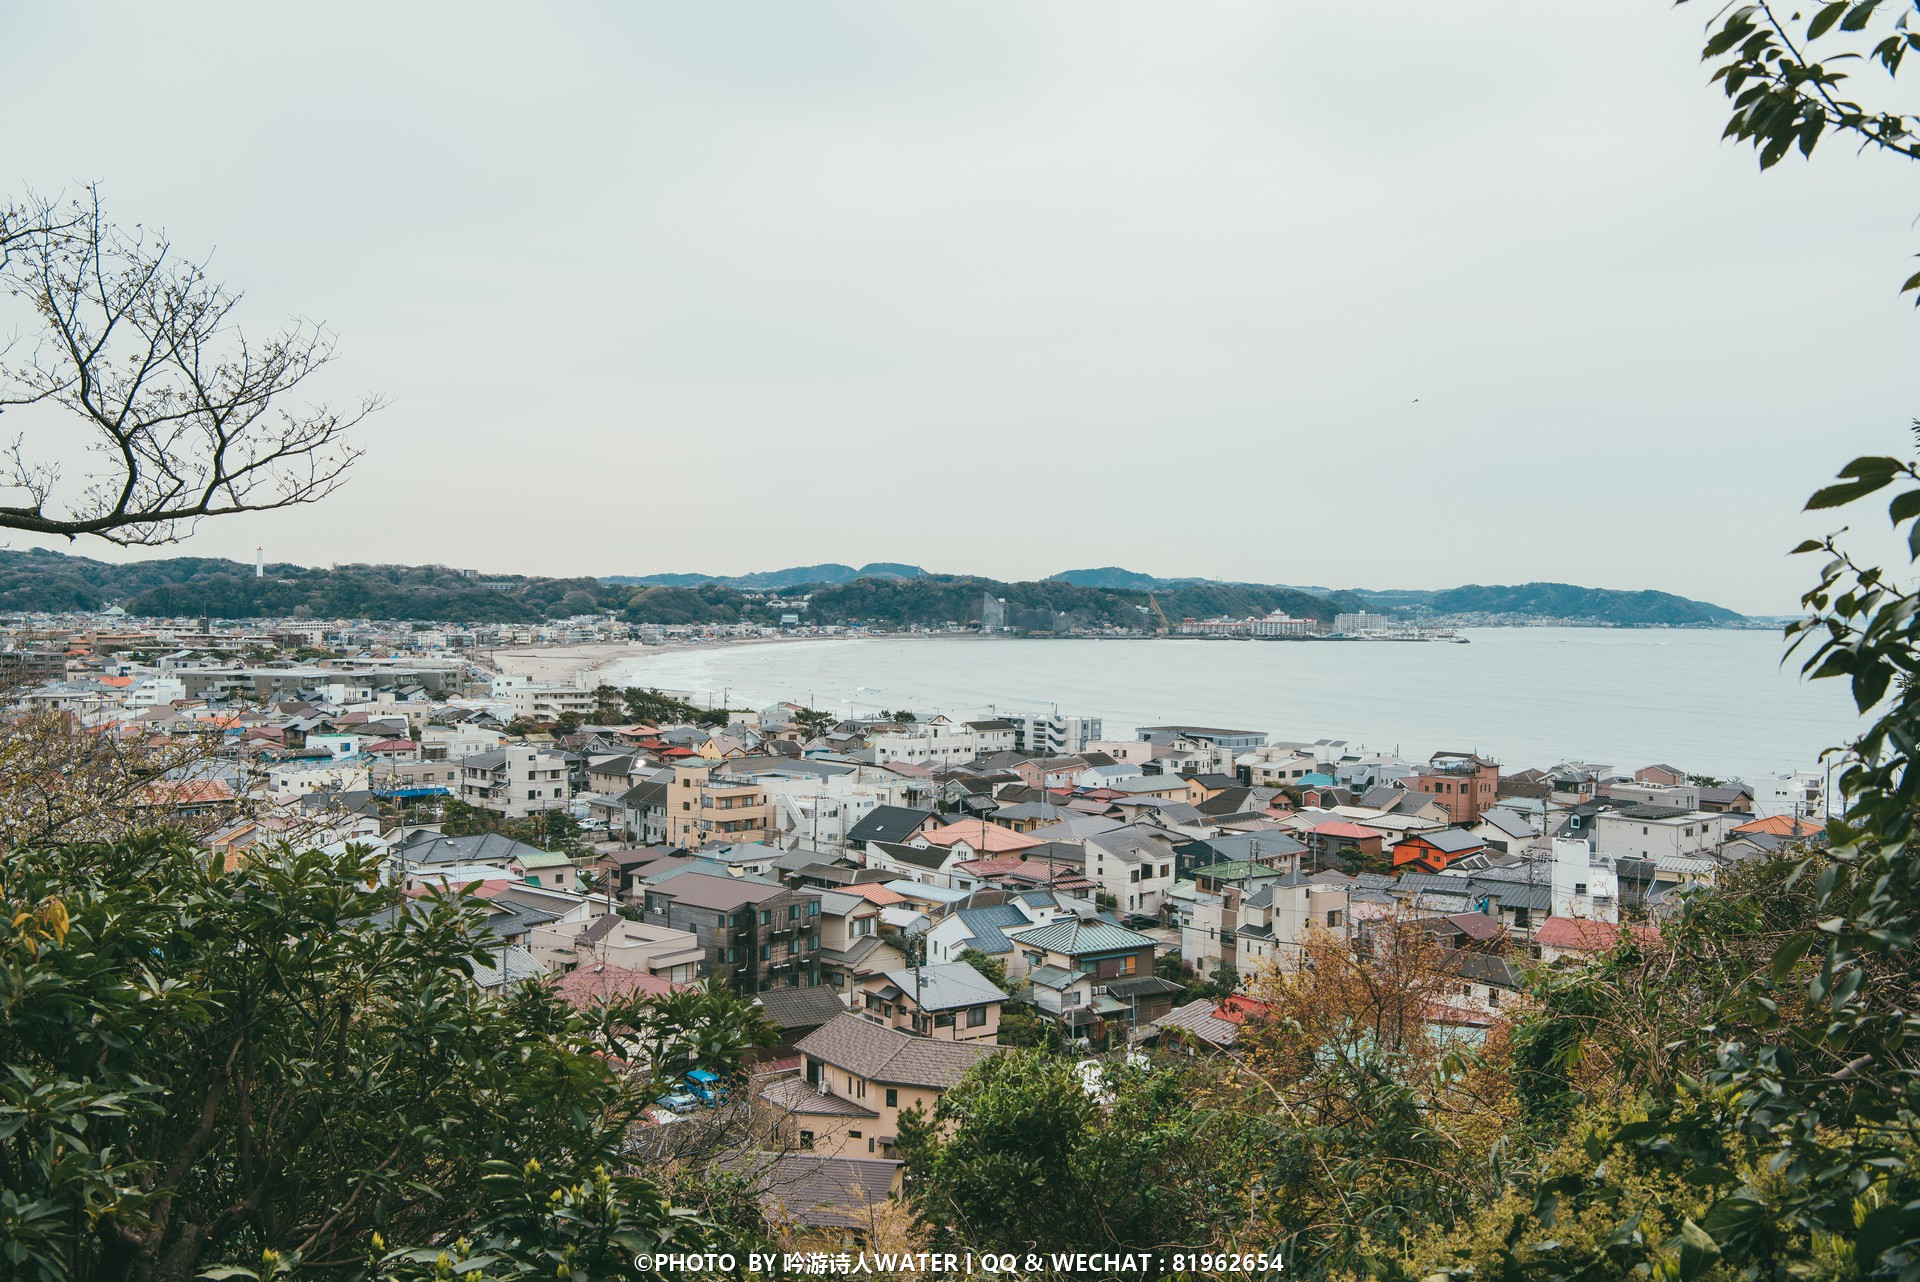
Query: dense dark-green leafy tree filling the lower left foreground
0,835,739,1282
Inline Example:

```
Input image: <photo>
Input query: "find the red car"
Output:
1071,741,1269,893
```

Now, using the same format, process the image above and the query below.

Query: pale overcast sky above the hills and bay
0,0,1920,614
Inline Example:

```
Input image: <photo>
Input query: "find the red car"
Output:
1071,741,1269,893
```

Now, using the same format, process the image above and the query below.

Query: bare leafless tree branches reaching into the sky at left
0,190,378,545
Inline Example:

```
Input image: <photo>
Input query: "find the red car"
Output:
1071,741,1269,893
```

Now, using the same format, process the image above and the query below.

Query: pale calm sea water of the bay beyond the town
603,628,1860,777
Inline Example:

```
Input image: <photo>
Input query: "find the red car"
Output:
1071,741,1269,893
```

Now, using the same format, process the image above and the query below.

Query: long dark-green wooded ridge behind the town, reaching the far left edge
0,551,1359,629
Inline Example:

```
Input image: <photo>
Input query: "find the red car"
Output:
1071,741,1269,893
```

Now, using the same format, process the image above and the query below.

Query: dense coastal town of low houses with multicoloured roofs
0,612,1828,1251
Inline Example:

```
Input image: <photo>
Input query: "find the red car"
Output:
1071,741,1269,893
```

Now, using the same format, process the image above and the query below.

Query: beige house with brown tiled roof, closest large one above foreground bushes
760,1015,995,1157
